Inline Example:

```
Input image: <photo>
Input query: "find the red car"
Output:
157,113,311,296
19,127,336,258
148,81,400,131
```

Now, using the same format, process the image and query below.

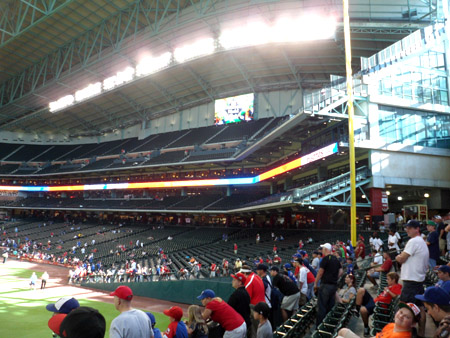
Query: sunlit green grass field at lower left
0,264,169,338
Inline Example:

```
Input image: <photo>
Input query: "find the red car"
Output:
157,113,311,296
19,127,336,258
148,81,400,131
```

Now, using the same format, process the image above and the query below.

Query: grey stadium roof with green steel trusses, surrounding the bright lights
0,0,441,136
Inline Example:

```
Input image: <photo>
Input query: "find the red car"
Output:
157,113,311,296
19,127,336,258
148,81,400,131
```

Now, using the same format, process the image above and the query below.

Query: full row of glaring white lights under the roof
49,15,336,113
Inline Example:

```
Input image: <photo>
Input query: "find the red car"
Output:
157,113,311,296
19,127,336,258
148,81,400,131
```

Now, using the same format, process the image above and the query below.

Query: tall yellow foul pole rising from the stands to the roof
343,0,356,246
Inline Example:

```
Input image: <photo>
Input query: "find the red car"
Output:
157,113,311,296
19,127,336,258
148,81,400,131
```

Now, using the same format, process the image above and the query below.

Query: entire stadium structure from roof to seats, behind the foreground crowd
0,0,450,338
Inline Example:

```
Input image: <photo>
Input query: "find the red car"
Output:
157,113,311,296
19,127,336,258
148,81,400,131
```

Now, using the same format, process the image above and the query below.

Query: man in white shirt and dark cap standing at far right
395,220,429,337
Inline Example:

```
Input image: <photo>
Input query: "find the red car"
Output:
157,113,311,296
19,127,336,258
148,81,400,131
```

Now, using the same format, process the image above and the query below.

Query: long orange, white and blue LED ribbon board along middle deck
0,143,339,191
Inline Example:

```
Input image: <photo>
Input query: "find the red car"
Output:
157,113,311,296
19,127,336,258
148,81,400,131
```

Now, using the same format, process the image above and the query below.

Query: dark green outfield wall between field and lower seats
81,277,234,305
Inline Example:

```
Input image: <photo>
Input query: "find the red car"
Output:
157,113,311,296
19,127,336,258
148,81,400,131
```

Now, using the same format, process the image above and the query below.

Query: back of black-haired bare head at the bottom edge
60,306,106,338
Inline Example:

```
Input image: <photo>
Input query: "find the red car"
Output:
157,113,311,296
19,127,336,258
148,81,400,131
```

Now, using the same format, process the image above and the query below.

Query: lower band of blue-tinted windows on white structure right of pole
378,105,450,149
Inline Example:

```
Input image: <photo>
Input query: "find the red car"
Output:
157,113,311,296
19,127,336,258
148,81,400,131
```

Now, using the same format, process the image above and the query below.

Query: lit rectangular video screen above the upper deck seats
214,93,255,125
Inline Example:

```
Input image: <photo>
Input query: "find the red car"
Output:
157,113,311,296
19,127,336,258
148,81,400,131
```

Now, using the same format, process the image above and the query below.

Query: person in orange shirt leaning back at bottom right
337,303,420,338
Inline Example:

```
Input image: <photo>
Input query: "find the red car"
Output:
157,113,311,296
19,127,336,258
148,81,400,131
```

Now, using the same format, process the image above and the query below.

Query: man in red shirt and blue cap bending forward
197,289,247,338
